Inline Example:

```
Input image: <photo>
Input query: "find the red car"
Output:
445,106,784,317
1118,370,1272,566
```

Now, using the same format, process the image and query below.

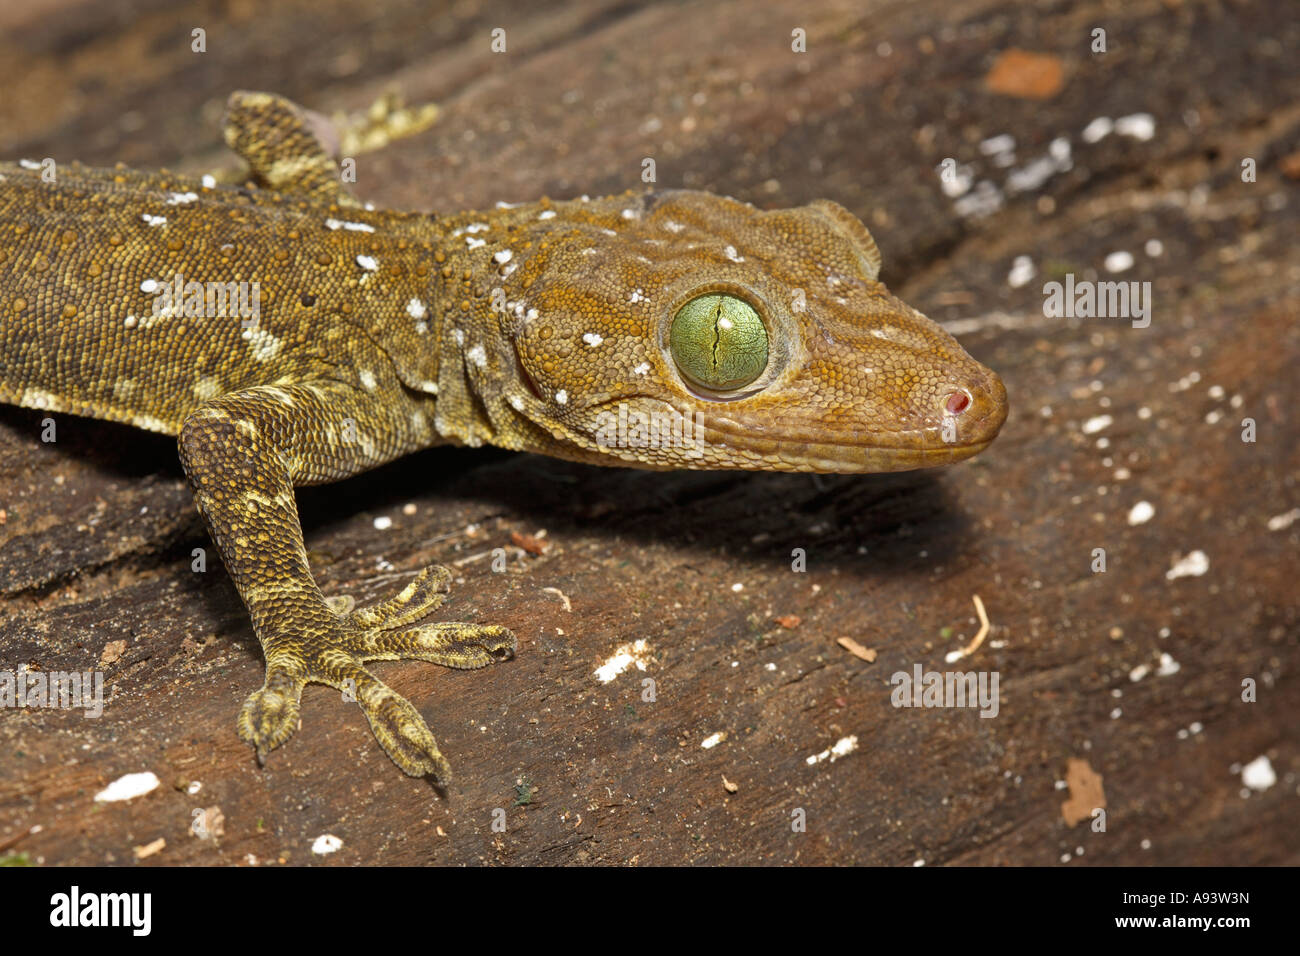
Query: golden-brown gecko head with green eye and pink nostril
496,191,1006,473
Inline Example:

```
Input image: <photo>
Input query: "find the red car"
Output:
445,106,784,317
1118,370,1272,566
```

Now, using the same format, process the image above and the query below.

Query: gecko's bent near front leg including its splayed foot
179,381,515,783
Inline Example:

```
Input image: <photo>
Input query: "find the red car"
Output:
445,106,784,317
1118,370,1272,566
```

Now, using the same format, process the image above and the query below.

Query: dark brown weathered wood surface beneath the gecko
0,0,1300,866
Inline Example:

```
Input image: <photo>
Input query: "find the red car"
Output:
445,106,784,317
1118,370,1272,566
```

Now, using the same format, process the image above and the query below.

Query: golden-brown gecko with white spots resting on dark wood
0,91,1008,786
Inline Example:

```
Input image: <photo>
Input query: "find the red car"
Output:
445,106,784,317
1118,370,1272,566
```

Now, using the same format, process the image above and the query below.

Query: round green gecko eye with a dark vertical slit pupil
668,294,767,392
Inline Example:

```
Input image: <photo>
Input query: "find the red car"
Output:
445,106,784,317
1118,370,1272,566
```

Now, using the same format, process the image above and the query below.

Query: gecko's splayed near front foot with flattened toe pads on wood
239,567,515,784
